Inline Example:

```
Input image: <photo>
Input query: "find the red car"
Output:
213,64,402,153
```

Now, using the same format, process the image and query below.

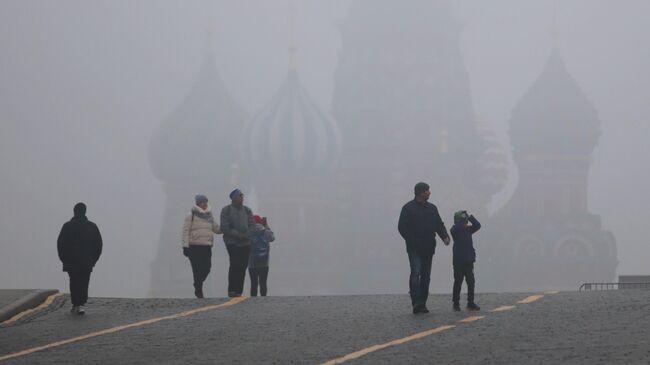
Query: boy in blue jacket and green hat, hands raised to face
450,210,481,311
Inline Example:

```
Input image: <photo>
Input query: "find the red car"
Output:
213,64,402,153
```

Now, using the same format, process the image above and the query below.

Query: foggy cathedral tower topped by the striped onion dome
241,68,341,295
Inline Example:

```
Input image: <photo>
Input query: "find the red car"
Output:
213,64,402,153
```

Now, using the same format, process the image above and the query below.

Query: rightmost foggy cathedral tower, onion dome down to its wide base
481,49,618,290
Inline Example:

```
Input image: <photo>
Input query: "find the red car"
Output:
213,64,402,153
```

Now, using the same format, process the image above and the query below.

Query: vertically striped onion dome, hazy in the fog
240,69,341,176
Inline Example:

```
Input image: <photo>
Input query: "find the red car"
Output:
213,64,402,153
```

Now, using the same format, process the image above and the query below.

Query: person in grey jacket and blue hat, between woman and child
221,189,255,298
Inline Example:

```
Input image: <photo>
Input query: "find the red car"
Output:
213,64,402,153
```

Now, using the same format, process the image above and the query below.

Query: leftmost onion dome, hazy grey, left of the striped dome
149,51,244,185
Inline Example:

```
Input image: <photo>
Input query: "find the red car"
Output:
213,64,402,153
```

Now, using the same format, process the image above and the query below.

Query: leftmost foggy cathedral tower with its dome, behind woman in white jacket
149,44,244,297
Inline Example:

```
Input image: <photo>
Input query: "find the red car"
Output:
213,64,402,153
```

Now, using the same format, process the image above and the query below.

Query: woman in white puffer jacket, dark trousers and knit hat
183,194,221,298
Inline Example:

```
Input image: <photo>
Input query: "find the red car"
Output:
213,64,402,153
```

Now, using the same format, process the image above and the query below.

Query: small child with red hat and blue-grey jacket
248,215,275,297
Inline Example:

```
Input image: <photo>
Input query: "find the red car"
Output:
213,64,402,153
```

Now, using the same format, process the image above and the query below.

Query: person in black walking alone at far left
57,203,102,314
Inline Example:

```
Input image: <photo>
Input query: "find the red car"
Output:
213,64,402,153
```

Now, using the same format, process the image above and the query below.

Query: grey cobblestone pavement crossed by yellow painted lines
0,290,650,364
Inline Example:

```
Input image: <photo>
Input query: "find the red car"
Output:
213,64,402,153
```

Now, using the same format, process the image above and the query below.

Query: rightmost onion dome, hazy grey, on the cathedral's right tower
510,49,600,159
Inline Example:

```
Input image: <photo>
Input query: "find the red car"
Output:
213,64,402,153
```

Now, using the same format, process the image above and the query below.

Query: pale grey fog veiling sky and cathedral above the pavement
0,0,650,297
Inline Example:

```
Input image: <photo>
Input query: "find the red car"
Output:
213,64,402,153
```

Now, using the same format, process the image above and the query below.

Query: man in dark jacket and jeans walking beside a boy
397,182,449,314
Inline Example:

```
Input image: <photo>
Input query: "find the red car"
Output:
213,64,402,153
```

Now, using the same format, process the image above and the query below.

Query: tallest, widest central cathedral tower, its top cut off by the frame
333,0,493,292
